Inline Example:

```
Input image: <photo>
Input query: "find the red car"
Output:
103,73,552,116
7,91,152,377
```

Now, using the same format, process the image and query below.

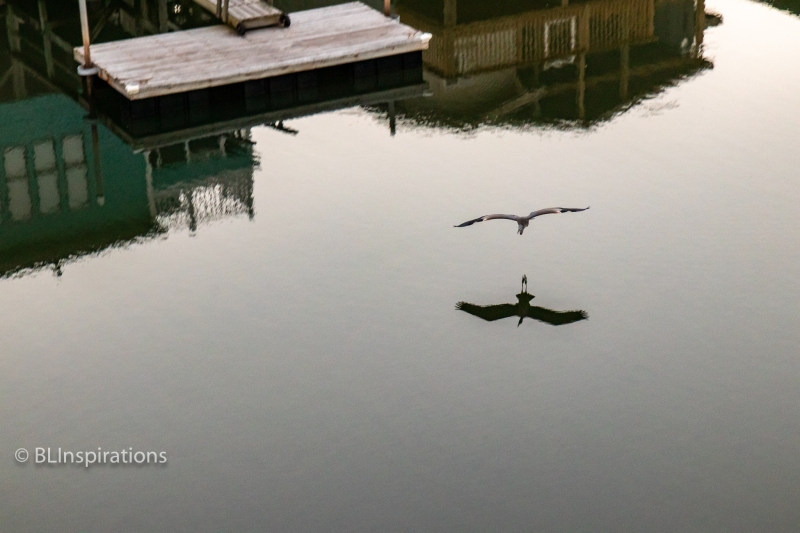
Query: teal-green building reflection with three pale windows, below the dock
0,87,256,277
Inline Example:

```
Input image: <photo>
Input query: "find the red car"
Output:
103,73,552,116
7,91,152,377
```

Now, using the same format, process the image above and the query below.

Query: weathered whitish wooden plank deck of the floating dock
74,2,431,100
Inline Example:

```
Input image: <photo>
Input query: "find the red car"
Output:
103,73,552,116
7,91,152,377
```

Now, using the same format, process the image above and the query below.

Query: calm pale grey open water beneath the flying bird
0,0,800,532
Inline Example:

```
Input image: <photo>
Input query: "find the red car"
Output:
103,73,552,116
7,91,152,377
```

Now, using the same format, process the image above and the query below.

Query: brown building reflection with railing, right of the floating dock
390,0,712,128
